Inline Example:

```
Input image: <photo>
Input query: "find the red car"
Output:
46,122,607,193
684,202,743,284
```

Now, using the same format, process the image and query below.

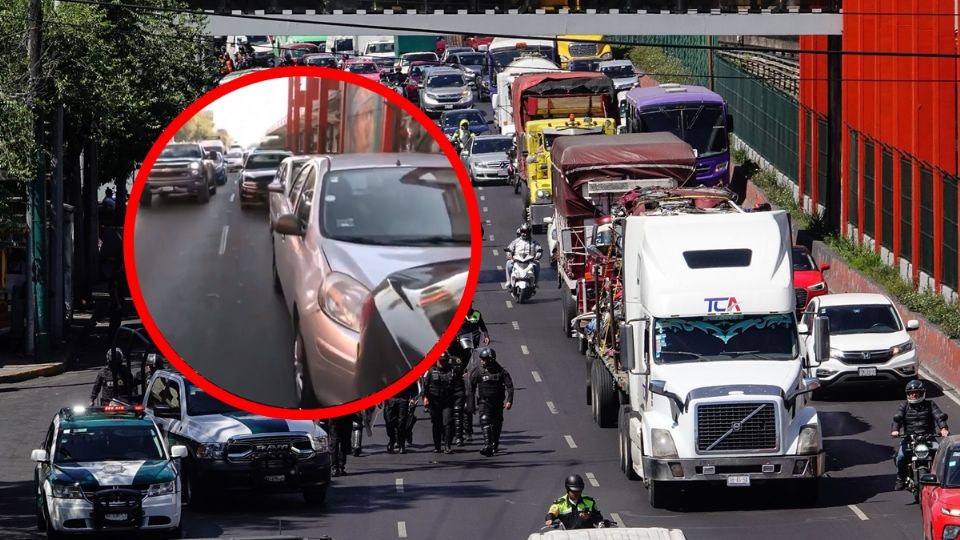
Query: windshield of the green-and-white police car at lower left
53,420,165,463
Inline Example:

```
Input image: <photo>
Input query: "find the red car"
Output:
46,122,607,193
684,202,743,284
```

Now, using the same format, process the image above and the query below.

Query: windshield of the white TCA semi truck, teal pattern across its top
653,313,798,364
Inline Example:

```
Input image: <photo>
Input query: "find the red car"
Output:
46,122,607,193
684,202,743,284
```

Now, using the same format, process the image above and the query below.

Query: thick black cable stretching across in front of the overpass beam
60,0,960,60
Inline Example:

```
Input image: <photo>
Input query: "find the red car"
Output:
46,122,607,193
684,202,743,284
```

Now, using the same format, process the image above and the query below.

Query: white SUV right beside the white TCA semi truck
803,293,920,388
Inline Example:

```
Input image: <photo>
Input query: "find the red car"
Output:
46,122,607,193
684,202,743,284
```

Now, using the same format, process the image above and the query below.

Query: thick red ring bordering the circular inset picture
123,66,483,420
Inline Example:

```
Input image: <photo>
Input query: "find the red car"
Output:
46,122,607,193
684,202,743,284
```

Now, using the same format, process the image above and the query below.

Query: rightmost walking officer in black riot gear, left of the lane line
470,347,513,456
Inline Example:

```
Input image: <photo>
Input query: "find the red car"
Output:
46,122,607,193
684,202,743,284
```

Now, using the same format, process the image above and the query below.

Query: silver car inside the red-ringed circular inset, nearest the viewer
271,153,470,408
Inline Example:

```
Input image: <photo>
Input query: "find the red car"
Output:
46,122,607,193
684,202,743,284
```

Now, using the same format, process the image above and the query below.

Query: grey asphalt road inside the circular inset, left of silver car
134,173,297,407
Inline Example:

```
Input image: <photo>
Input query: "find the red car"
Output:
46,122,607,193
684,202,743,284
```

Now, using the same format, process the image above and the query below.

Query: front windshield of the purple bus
639,105,727,157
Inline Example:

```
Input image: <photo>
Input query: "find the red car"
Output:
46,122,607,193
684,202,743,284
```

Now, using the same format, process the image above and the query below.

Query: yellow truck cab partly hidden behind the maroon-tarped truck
518,114,618,225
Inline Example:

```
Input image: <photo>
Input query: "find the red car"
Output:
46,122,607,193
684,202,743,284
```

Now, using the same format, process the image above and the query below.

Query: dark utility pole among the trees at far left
26,0,46,358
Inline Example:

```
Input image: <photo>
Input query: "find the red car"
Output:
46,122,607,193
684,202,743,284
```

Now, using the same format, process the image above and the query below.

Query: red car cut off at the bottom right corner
920,435,960,540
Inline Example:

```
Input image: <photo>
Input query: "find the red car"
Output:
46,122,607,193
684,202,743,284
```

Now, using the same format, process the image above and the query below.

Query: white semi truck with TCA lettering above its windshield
587,188,829,508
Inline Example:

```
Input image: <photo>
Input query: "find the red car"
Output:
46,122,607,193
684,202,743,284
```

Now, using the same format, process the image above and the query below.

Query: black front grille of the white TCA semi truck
697,402,779,453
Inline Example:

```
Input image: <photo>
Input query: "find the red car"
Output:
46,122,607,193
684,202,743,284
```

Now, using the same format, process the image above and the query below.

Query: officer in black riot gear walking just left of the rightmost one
423,352,465,454
